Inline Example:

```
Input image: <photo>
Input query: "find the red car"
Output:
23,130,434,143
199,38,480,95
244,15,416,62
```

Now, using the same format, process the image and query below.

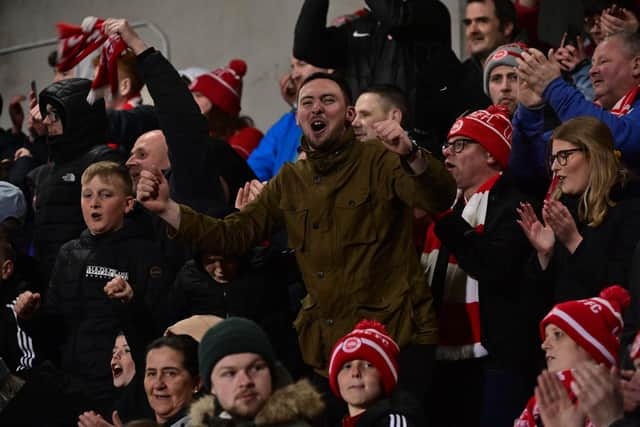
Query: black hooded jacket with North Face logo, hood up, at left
34,78,124,278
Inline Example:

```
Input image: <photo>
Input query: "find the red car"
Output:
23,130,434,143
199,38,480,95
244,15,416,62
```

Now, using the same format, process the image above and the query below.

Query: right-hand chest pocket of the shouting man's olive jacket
335,191,377,246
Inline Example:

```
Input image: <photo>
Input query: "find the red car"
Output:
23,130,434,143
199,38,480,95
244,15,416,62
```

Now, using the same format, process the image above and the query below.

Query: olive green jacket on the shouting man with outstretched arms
175,131,456,374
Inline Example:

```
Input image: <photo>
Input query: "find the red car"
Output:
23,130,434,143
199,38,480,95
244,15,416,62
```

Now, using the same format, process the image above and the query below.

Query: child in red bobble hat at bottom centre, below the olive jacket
329,320,421,427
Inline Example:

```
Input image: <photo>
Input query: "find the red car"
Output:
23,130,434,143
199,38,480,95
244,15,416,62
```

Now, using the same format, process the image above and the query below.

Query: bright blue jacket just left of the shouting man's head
247,111,302,181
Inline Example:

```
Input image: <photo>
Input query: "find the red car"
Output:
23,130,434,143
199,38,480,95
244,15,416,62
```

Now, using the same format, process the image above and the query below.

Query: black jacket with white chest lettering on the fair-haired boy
27,227,168,400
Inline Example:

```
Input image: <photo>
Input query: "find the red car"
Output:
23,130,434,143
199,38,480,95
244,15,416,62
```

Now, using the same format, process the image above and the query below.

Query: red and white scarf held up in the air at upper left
56,17,127,104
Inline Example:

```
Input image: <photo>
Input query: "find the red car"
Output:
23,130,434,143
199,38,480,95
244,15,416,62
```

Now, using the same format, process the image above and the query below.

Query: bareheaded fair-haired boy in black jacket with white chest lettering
16,162,167,422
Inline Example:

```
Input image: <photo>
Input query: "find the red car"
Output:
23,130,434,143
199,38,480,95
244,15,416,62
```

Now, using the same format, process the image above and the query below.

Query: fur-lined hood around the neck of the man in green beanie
189,380,324,427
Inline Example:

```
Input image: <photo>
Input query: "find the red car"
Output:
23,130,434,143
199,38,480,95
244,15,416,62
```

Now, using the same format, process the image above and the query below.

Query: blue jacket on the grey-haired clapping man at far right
509,77,640,177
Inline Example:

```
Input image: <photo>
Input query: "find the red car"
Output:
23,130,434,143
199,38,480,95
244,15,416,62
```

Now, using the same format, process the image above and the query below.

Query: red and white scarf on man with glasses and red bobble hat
420,173,501,360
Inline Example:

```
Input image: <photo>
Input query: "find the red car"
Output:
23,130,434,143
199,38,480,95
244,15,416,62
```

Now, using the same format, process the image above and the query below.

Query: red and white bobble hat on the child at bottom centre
329,320,400,397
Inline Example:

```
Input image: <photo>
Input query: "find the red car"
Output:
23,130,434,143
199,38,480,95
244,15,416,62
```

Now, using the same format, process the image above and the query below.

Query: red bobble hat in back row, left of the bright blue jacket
189,59,247,116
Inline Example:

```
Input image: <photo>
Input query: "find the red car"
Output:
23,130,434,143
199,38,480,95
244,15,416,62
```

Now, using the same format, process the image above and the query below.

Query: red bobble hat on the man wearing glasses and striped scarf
447,105,512,169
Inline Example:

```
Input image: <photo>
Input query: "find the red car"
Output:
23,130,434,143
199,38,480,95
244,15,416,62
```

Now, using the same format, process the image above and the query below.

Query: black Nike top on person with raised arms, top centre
293,0,465,153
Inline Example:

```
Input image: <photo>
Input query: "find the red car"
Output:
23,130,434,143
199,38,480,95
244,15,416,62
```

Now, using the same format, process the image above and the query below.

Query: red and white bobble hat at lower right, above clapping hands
540,285,631,367
